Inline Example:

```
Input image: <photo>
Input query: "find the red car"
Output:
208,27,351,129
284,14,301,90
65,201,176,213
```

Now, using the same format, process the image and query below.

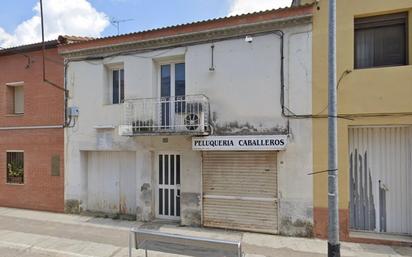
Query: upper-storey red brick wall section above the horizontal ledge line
0,48,64,127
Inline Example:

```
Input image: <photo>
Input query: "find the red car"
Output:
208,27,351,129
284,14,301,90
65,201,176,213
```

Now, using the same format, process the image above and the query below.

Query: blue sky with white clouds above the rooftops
0,0,291,48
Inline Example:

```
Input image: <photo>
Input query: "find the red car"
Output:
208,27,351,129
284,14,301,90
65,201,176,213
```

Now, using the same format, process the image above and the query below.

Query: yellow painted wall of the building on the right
310,0,412,209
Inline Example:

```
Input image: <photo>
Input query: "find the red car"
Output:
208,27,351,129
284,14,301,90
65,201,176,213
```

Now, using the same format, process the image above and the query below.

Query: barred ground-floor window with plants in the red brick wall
6,151,24,184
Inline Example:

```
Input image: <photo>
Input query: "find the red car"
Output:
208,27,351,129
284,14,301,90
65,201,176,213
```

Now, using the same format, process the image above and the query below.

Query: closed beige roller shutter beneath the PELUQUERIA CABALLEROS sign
202,152,278,233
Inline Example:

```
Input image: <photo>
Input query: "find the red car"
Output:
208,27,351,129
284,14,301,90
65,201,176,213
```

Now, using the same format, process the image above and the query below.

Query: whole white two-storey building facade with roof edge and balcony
60,7,313,235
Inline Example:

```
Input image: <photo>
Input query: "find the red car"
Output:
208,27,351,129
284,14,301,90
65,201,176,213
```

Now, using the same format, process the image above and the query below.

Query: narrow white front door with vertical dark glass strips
156,154,180,219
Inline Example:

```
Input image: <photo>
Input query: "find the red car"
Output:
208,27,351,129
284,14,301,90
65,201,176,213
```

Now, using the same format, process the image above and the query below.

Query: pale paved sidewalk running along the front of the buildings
0,207,412,257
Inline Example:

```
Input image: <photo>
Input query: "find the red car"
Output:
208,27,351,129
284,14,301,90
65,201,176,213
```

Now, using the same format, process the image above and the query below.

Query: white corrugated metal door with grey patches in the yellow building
349,126,412,235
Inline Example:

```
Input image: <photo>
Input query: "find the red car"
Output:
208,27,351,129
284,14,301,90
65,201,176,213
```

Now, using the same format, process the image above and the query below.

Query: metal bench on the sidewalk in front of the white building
129,228,242,257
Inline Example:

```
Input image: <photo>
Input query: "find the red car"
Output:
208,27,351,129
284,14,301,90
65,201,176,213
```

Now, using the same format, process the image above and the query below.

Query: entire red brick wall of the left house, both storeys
0,48,64,212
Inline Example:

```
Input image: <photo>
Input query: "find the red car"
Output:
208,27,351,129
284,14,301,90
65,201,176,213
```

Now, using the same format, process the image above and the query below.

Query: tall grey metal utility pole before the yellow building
328,0,340,254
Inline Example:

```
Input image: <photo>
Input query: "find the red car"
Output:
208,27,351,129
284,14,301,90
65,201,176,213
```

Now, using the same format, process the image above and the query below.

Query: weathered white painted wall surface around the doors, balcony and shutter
65,25,312,234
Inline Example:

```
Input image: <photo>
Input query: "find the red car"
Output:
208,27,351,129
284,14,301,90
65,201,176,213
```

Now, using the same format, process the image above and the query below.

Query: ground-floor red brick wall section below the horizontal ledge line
0,129,64,212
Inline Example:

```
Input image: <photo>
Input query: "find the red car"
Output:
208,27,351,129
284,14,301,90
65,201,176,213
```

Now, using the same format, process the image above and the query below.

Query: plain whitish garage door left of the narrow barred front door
87,151,136,214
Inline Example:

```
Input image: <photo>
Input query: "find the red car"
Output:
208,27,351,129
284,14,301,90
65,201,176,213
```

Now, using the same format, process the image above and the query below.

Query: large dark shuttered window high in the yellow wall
355,13,408,69
